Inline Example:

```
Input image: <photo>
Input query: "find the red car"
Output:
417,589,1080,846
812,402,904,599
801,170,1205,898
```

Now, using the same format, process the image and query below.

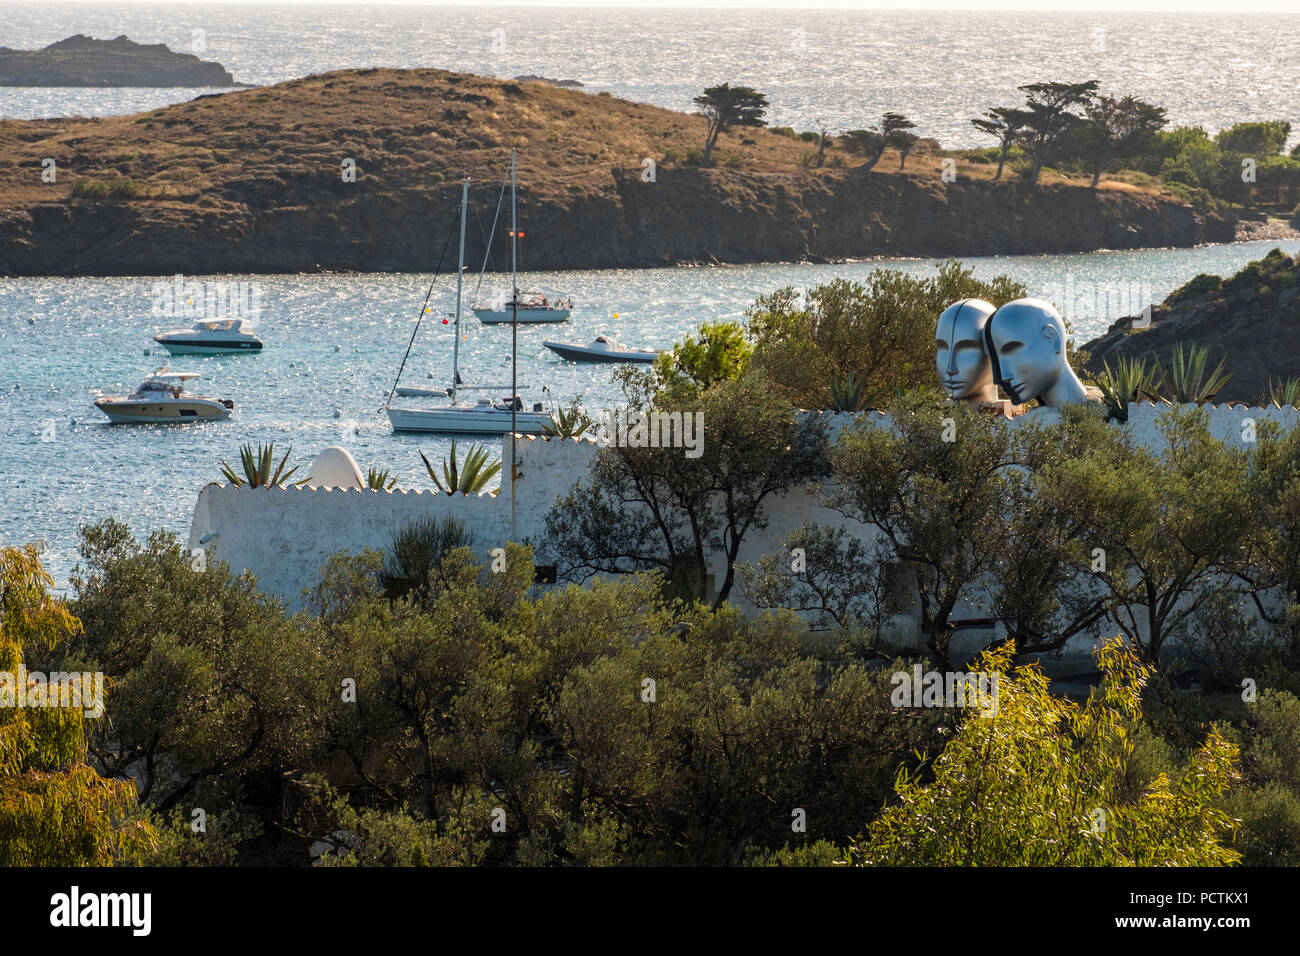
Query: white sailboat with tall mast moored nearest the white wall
387,161,554,434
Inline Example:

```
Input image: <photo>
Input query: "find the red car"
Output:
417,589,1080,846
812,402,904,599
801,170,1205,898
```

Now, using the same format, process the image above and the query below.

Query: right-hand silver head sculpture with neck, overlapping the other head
984,299,1088,406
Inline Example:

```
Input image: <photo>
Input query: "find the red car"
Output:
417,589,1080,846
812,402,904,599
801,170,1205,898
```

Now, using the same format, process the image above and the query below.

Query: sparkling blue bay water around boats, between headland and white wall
0,235,1300,583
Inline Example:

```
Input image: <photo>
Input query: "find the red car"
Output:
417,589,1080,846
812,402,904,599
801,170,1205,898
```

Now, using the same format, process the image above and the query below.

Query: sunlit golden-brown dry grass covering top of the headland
0,69,1180,215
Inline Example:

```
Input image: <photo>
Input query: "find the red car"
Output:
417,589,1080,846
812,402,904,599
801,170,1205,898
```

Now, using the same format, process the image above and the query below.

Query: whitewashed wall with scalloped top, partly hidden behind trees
190,403,1300,658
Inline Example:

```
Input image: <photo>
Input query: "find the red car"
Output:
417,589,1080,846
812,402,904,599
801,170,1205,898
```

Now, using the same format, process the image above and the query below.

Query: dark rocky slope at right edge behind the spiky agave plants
1083,250,1300,402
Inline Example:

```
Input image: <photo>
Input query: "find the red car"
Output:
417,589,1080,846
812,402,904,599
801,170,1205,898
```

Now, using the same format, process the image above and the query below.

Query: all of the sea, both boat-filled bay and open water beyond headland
0,1,1300,589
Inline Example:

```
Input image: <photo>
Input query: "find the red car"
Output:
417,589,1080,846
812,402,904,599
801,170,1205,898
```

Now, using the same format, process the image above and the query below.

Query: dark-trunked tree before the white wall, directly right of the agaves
543,369,826,606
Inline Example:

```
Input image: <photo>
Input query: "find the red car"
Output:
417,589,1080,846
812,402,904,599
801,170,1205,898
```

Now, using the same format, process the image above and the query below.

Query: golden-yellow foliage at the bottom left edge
0,545,156,866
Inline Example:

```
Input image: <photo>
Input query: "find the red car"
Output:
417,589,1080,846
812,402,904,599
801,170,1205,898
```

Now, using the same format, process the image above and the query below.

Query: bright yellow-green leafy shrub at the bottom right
852,641,1240,866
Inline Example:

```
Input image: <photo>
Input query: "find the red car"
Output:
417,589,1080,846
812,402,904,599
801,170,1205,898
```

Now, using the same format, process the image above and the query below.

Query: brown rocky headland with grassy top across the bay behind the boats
0,70,1232,274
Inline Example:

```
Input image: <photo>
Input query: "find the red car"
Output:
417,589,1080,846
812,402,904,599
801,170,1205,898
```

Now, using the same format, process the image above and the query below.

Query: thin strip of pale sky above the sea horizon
17,0,1300,14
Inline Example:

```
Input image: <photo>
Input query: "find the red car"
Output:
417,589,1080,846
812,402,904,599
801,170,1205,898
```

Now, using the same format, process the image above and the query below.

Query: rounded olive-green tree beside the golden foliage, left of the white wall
64,520,315,816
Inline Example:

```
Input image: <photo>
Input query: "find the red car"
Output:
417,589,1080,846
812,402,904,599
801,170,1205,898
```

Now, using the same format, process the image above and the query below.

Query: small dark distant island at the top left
0,34,243,87
